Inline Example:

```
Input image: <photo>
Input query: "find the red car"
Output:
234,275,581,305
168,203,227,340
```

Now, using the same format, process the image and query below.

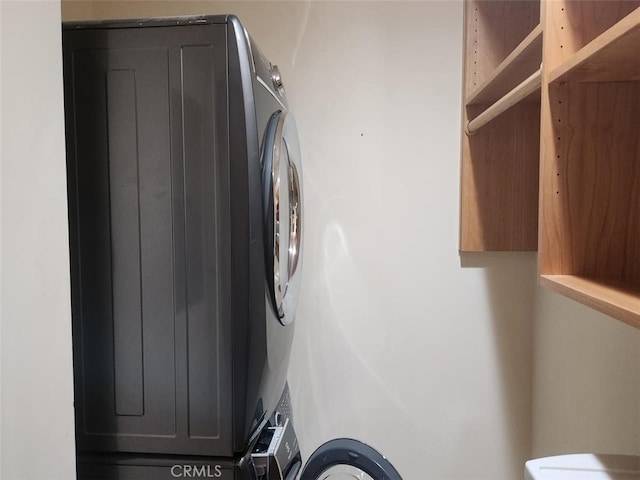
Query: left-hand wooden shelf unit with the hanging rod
459,0,542,252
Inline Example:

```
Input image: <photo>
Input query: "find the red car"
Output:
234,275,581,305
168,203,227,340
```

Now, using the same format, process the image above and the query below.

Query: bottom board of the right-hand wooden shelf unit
540,275,640,329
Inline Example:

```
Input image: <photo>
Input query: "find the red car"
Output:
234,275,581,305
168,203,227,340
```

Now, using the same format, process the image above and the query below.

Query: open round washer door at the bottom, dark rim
300,438,402,480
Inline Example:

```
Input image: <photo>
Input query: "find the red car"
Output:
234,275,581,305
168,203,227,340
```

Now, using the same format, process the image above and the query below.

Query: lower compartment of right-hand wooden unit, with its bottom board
539,82,640,327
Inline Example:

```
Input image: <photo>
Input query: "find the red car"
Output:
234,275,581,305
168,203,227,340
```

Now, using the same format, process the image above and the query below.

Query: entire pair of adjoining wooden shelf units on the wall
460,0,640,328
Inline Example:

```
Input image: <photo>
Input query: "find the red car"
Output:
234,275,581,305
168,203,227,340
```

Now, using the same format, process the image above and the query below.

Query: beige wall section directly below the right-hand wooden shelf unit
533,289,640,457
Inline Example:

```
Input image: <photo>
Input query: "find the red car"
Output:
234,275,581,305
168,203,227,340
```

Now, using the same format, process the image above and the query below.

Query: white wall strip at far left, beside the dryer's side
0,0,75,480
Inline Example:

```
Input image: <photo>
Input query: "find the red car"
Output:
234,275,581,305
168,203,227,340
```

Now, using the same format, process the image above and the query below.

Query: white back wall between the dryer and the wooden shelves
264,2,535,479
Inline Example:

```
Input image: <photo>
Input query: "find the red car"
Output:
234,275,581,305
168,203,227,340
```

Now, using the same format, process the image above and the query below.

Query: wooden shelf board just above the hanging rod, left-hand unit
465,24,542,105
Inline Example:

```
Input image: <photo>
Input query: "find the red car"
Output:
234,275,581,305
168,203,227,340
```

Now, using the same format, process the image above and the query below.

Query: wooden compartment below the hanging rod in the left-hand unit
459,103,540,252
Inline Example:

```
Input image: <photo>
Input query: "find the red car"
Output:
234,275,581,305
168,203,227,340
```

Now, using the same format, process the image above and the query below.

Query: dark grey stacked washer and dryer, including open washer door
63,15,399,480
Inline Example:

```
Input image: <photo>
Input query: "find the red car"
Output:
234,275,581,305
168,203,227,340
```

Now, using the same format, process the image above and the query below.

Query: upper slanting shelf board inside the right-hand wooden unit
549,7,640,82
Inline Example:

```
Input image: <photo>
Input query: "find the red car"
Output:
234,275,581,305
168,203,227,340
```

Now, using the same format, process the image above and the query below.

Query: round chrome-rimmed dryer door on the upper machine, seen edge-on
262,111,302,325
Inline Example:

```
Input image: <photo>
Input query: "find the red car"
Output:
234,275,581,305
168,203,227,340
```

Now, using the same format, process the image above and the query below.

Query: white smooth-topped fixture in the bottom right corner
524,453,640,480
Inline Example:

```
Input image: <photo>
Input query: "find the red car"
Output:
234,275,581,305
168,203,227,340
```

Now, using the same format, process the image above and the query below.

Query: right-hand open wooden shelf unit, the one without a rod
538,0,640,328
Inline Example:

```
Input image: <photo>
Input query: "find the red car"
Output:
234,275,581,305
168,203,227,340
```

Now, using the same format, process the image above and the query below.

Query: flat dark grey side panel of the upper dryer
64,25,233,455
